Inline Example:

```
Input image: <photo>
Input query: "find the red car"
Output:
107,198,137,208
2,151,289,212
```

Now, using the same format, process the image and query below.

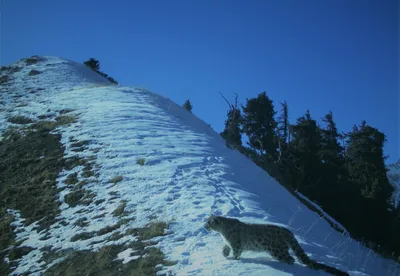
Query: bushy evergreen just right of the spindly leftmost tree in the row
243,92,278,161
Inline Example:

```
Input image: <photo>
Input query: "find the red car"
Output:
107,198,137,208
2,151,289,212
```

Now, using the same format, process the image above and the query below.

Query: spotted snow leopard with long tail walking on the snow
205,215,349,276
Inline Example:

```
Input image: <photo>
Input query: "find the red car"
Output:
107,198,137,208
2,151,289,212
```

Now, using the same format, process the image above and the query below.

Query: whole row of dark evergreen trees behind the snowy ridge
221,92,400,259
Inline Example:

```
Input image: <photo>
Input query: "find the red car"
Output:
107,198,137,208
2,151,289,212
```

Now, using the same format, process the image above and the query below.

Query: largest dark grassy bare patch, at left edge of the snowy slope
0,127,64,275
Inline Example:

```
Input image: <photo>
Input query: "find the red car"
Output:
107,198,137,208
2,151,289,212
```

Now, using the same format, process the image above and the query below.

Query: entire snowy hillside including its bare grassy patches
0,56,400,276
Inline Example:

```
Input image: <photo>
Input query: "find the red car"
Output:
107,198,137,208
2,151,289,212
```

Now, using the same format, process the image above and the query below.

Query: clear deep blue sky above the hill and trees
0,0,400,162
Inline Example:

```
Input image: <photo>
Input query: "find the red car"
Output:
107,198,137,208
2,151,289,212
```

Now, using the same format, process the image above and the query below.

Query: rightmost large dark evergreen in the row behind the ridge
346,121,393,246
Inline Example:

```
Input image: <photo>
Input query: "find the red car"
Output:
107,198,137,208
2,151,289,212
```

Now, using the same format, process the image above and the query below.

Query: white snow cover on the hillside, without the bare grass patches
0,57,400,275
